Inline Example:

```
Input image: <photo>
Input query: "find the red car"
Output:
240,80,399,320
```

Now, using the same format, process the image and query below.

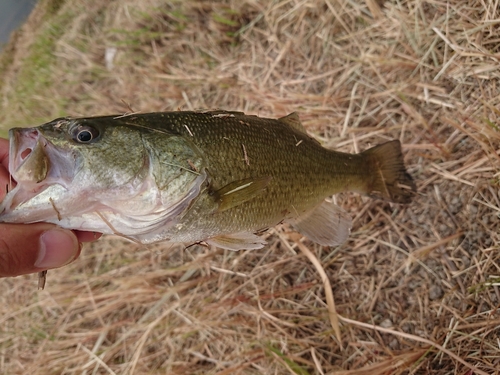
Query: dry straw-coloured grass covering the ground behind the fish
0,0,500,375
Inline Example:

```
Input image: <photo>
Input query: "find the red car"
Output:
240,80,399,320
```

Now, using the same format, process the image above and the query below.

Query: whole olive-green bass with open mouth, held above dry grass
0,110,416,250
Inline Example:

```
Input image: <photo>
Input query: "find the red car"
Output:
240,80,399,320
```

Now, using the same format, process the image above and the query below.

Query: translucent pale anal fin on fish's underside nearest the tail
290,201,352,246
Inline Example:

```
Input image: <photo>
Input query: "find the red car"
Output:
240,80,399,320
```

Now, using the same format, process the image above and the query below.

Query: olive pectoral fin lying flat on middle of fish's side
215,176,271,212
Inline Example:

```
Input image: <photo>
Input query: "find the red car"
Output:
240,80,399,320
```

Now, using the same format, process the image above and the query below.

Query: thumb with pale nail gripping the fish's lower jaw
0,223,80,277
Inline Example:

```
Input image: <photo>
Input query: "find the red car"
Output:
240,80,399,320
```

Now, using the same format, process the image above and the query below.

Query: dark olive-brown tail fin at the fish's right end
362,140,416,203
